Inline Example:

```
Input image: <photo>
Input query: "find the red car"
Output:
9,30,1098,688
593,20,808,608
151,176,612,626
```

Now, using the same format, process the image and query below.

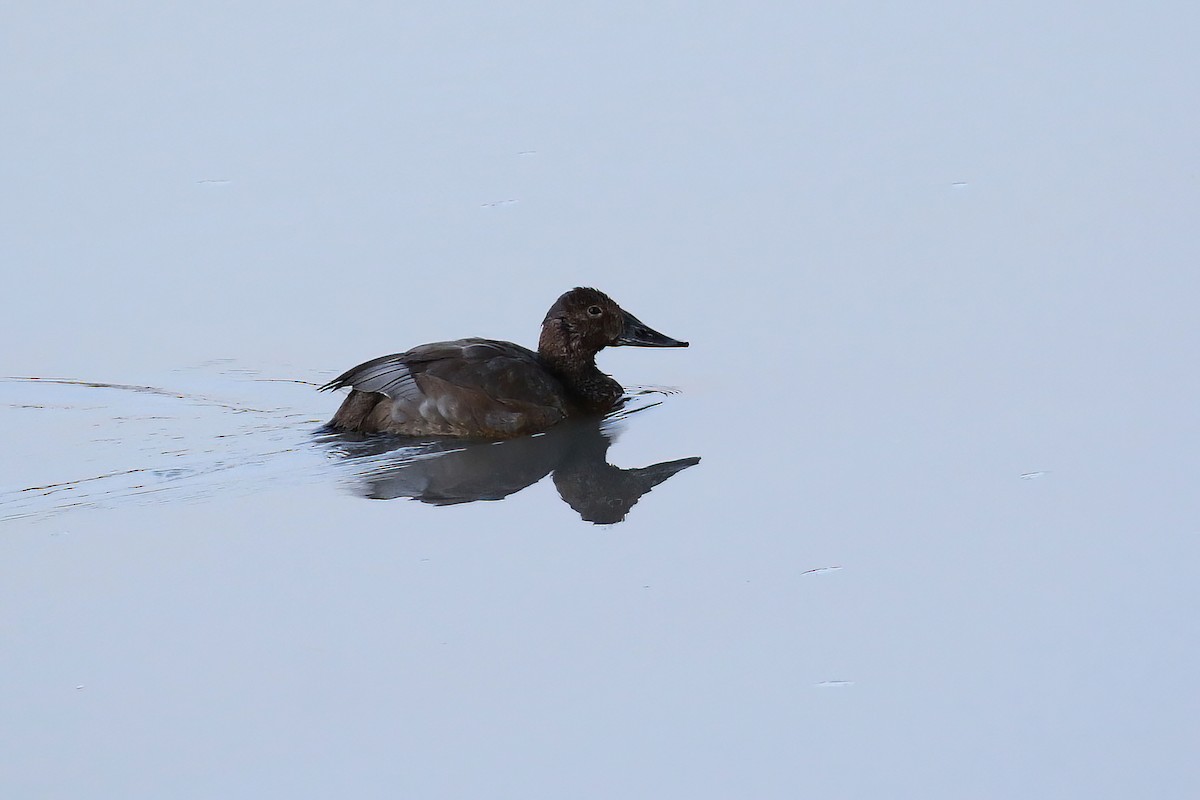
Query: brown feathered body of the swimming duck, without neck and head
322,338,569,439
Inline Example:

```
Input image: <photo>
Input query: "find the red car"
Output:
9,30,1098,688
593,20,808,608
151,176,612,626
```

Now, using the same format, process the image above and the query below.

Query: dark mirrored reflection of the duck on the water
324,412,700,524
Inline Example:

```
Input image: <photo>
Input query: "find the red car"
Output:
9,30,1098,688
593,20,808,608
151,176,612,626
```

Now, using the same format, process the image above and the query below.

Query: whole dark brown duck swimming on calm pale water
320,287,688,440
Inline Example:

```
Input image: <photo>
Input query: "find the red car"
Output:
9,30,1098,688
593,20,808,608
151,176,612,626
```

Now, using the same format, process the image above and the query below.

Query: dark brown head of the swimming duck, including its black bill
538,287,688,361
